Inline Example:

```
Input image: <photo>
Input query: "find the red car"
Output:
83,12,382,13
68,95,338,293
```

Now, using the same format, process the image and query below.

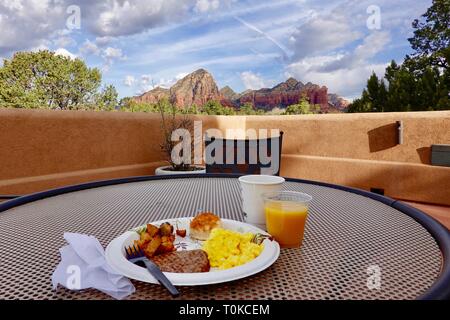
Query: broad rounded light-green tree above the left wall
0,50,101,109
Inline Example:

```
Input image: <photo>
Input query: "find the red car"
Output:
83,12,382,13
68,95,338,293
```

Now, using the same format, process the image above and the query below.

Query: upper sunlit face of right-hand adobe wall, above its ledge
246,111,450,164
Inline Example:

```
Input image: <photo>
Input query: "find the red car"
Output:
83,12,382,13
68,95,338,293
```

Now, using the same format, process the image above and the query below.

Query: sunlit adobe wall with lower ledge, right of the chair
246,111,450,205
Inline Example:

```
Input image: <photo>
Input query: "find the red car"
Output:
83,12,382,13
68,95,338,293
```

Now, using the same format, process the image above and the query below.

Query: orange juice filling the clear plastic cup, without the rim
264,200,308,248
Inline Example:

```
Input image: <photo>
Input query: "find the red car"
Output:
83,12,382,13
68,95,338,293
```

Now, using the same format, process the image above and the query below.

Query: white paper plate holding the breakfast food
105,218,280,286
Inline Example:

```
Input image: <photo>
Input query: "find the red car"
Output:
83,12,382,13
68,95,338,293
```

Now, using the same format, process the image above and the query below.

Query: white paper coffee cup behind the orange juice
239,175,285,230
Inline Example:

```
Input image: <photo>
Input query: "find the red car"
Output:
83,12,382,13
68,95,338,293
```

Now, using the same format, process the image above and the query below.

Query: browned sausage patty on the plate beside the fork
152,249,210,273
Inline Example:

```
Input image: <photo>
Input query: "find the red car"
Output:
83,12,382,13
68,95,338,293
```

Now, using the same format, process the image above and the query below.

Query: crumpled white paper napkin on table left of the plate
52,233,135,299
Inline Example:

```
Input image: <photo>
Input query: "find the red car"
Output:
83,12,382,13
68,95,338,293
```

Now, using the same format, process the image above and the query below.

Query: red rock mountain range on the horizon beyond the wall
133,69,348,113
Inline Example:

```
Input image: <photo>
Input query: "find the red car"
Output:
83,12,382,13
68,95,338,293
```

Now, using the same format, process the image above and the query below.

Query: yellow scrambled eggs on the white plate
203,228,264,270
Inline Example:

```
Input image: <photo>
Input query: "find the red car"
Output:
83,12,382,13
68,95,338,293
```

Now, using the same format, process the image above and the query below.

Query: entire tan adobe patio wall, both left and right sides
0,109,450,205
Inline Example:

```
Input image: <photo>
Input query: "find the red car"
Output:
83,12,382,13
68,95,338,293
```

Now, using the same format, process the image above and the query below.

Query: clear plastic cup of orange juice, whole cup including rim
264,191,312,248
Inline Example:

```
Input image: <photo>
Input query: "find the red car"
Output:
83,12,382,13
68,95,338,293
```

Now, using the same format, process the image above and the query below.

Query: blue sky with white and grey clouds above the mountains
0,0,431,99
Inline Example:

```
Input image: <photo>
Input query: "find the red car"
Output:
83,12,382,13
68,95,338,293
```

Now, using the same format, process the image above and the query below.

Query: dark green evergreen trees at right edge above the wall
348,0,450,112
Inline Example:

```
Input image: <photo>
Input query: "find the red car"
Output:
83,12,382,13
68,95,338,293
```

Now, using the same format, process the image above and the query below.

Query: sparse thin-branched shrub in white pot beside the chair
155,99,206,175
